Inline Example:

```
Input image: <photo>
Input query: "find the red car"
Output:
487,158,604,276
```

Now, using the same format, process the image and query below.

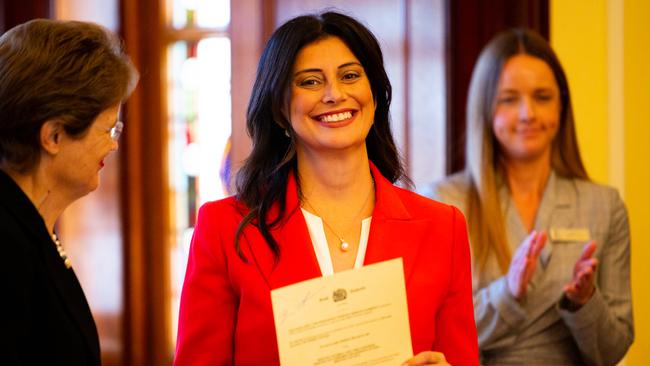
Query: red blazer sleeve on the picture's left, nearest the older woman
174,206,237,366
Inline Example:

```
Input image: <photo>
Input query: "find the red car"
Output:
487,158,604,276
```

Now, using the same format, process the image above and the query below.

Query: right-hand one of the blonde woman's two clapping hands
564,240,598,308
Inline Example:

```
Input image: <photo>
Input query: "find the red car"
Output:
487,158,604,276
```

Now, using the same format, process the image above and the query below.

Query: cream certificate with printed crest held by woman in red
271,258,413,366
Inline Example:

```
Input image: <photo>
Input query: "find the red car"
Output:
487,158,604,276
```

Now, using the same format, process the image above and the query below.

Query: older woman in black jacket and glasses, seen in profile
0,19,138,365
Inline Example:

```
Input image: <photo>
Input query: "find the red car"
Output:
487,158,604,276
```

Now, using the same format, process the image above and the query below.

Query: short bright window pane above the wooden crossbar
172,0,230,29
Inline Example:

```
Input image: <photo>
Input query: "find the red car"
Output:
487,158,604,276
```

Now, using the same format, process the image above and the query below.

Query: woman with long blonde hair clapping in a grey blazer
424,30,634,365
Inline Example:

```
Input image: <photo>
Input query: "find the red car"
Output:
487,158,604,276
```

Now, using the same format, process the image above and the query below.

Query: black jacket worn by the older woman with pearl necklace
0,170,101,366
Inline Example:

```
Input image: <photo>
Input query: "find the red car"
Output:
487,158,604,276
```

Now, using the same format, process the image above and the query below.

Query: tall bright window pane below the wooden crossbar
168,37,231,339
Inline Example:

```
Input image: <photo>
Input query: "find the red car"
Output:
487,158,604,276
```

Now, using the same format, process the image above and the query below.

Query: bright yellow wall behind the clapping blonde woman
551,0,650,366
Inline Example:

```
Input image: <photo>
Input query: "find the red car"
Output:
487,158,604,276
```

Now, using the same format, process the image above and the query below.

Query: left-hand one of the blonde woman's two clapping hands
506,230,547,300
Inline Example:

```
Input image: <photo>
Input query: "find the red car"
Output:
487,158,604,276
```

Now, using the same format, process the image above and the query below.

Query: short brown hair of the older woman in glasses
0,19,138,172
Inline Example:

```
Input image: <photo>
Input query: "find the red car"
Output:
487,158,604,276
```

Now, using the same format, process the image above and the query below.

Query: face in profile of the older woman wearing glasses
52,105,120,197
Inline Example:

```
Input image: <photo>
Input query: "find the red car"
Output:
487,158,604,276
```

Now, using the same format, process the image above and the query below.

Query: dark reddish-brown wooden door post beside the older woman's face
120,0,173,366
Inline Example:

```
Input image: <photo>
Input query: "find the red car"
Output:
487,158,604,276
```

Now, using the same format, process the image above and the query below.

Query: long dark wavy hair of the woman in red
235,11,410,260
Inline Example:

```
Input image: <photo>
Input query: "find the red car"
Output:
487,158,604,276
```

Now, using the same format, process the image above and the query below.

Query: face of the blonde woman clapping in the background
492,54,561,163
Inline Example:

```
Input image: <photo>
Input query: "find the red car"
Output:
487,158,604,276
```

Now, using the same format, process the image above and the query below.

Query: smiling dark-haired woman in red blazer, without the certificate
175,12,478,366
